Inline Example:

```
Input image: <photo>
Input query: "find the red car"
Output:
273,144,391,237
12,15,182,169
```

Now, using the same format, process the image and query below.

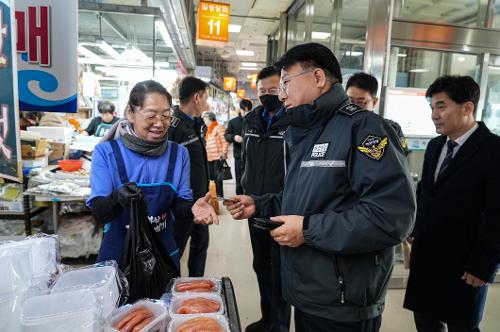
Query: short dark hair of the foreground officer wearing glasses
274,43,342,83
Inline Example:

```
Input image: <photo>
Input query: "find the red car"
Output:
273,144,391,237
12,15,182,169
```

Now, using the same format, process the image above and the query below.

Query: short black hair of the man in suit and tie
425,75,480,112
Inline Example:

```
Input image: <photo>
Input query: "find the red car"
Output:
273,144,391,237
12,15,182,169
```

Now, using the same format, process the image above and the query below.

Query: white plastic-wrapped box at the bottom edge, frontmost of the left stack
20,289,100,332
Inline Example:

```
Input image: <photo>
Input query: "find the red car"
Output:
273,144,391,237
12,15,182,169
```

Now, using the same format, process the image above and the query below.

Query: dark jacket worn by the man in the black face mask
241,106,290,195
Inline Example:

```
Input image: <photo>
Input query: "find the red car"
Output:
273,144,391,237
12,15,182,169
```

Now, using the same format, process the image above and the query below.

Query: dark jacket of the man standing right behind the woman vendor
168,106,208,201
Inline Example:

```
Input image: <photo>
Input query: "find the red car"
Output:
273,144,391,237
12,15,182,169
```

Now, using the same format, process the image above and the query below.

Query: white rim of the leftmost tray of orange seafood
105,300,167,332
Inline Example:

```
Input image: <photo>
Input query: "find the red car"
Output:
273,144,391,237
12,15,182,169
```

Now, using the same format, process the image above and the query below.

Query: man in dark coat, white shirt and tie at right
404,76,500,332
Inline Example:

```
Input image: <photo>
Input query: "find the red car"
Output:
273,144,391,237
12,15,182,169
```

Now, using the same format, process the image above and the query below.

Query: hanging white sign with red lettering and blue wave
15,0,78,113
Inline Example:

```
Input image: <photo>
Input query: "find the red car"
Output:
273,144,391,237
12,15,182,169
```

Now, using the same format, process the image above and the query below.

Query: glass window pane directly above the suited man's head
388,47,479,89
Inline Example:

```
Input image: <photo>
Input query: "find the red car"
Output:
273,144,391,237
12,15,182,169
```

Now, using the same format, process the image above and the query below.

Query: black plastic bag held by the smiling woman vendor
120,199,180,303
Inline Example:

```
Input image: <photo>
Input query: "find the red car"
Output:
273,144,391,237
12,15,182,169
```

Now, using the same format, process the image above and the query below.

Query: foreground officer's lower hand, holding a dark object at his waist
271,215,305,248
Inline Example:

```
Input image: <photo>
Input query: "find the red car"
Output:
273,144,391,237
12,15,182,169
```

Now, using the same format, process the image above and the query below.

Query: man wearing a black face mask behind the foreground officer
241,66,290,332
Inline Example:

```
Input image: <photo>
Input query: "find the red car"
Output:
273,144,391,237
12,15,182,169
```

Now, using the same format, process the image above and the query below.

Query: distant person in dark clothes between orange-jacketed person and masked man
224,99,252,195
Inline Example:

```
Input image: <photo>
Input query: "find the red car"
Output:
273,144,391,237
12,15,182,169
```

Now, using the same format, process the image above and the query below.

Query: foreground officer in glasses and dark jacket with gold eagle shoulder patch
226,43,415,332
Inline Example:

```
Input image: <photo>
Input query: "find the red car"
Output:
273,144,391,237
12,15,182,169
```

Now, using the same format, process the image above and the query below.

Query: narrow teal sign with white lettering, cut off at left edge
0,0,22,181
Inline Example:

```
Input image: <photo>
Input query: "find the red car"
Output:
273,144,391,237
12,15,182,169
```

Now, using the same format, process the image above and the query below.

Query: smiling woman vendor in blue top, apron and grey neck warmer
87,81,218,267
